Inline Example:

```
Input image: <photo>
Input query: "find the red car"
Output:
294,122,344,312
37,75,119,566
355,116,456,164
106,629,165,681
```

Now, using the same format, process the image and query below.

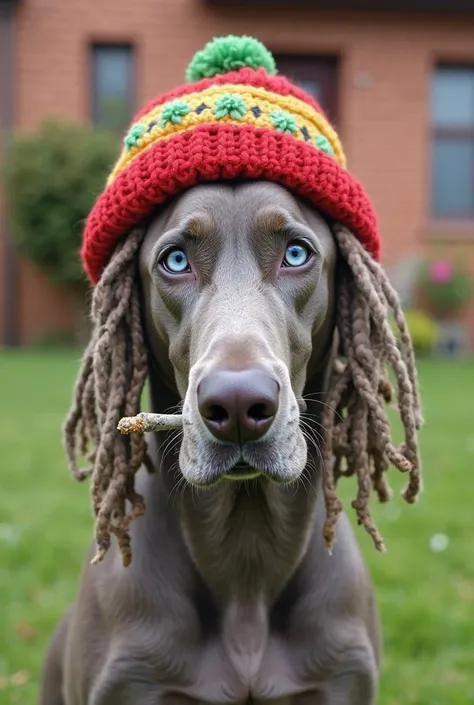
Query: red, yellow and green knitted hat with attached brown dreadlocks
64,36,422,565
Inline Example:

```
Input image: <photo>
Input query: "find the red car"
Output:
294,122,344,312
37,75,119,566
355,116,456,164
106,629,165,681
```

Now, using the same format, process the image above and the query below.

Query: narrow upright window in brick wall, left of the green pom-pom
91,44,134,131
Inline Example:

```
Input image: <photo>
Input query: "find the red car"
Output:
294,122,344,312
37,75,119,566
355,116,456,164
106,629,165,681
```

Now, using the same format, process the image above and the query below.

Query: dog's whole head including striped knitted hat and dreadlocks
64,35,422,563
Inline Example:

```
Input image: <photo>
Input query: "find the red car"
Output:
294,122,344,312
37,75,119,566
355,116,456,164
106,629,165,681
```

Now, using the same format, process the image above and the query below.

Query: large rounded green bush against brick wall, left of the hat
3,121,118,287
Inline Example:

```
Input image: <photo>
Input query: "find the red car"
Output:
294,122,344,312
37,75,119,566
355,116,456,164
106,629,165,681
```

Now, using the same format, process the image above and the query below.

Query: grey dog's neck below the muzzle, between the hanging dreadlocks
146,360,332,606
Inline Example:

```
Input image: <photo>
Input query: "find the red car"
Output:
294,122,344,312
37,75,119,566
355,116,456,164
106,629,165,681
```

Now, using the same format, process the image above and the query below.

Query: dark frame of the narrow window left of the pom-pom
87,39,137,131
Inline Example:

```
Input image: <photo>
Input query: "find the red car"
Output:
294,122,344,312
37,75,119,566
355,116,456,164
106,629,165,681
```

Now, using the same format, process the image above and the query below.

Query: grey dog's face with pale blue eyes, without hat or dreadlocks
140,182,336,486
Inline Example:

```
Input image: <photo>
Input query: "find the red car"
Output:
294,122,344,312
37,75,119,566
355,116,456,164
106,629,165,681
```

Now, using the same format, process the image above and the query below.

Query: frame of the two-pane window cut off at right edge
428,60,474,221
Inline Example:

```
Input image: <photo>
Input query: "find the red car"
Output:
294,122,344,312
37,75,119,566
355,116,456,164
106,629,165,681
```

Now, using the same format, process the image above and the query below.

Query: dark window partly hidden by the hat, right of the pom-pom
275,54,339,125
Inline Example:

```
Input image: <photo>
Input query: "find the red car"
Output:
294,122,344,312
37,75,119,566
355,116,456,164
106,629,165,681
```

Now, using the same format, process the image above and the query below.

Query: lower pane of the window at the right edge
432,137,474,218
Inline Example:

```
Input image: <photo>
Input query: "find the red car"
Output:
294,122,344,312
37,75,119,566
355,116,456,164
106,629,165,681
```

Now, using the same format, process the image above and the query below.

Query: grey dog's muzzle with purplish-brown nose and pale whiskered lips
179,363,307,487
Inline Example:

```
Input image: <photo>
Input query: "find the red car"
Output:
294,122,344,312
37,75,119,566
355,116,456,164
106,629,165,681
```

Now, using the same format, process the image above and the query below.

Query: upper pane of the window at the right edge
431,67,474,127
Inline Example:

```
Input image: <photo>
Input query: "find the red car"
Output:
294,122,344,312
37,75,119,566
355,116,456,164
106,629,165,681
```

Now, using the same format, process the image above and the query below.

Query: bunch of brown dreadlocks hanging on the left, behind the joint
63,229,147,565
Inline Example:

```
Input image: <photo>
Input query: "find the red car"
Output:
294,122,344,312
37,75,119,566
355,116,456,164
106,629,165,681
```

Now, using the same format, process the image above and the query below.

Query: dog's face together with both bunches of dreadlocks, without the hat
64,181,422,565
